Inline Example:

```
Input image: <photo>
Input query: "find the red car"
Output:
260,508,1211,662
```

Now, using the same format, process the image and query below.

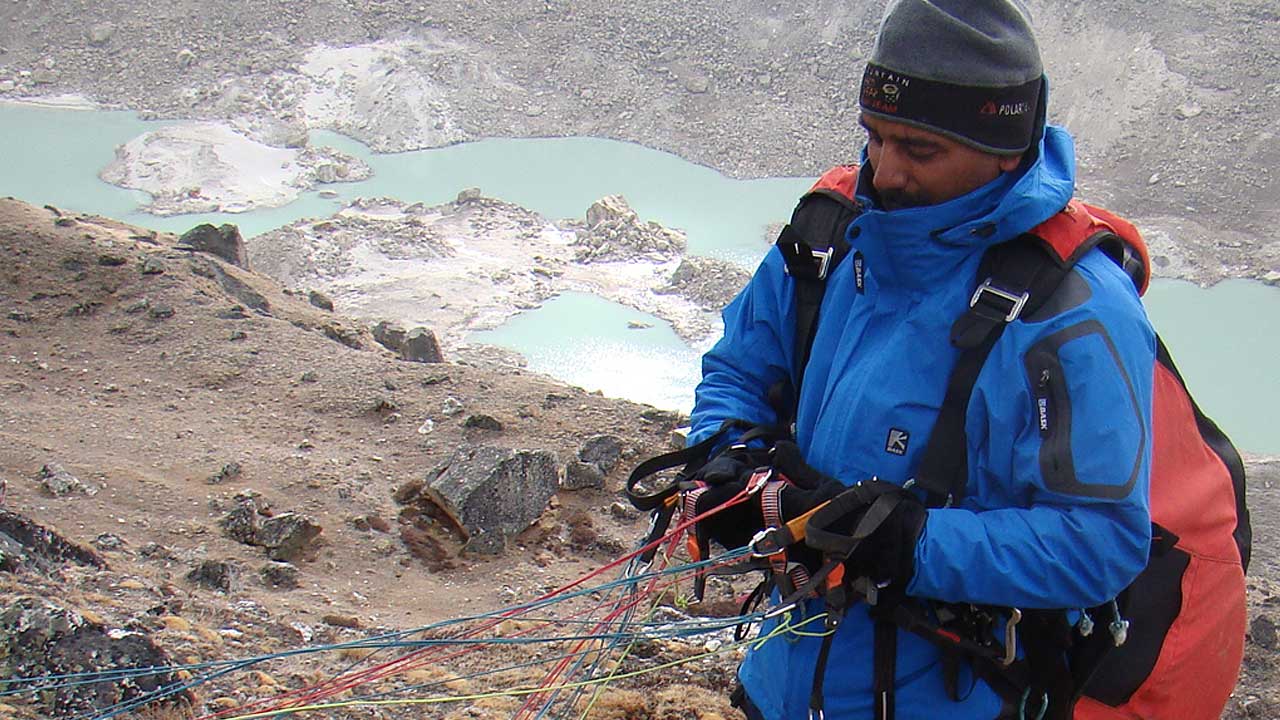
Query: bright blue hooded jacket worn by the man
690,127,1155,720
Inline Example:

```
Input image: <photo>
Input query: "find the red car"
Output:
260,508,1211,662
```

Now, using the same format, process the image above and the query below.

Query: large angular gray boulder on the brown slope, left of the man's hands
399,446,559,553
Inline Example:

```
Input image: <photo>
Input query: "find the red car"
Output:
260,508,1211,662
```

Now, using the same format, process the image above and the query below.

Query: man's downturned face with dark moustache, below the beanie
861,115,1021,210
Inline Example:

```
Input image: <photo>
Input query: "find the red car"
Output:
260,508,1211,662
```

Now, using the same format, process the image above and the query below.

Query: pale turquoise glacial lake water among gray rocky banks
0,102,1280,454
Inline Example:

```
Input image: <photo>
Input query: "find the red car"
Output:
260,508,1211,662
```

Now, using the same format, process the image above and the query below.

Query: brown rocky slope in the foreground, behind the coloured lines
0,200,1280,720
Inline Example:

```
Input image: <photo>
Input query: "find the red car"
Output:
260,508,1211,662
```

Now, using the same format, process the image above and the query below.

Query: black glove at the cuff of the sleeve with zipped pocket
805,479,928,589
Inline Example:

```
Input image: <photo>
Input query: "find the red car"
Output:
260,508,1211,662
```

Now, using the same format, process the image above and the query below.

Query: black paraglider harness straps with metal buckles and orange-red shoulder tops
627,167,1251,720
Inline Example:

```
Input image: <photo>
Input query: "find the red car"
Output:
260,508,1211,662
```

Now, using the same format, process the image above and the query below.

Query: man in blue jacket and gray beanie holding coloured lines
690,0,1155,720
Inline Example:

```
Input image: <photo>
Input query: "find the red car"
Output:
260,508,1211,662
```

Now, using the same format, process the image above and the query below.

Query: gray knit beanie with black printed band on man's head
860,0,1044,155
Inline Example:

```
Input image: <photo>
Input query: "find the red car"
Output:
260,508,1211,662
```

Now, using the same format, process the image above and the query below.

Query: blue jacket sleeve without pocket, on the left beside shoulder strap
689,249,795,445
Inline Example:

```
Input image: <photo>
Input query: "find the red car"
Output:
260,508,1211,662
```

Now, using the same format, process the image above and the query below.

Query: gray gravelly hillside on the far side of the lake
0,0,1280,281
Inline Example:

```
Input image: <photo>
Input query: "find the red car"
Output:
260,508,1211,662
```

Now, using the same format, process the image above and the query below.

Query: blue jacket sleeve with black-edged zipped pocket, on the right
908,260,1155,609
